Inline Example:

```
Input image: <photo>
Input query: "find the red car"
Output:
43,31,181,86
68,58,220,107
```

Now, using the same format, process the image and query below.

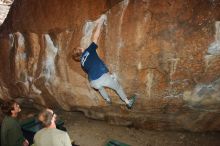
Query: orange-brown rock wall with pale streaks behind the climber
0,0,220,131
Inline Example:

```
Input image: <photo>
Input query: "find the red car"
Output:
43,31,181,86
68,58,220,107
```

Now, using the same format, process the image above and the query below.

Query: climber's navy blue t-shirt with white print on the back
80,42,109,81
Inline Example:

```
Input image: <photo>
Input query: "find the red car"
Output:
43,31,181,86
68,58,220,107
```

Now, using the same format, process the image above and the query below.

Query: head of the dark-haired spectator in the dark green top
1,100,21,117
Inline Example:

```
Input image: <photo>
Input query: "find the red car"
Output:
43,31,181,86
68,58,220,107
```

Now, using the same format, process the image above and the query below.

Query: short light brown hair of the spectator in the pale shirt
39,109,54,127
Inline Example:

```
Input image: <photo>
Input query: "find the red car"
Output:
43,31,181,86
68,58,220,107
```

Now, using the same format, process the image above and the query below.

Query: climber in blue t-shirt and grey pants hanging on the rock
72,14,136,109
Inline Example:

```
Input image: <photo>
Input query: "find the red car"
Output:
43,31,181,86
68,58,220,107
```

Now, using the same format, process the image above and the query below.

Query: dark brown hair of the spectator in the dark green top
1,100,17,116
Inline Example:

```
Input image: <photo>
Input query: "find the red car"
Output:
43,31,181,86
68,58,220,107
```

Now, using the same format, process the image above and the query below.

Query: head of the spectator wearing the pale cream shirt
39,109,56,127
